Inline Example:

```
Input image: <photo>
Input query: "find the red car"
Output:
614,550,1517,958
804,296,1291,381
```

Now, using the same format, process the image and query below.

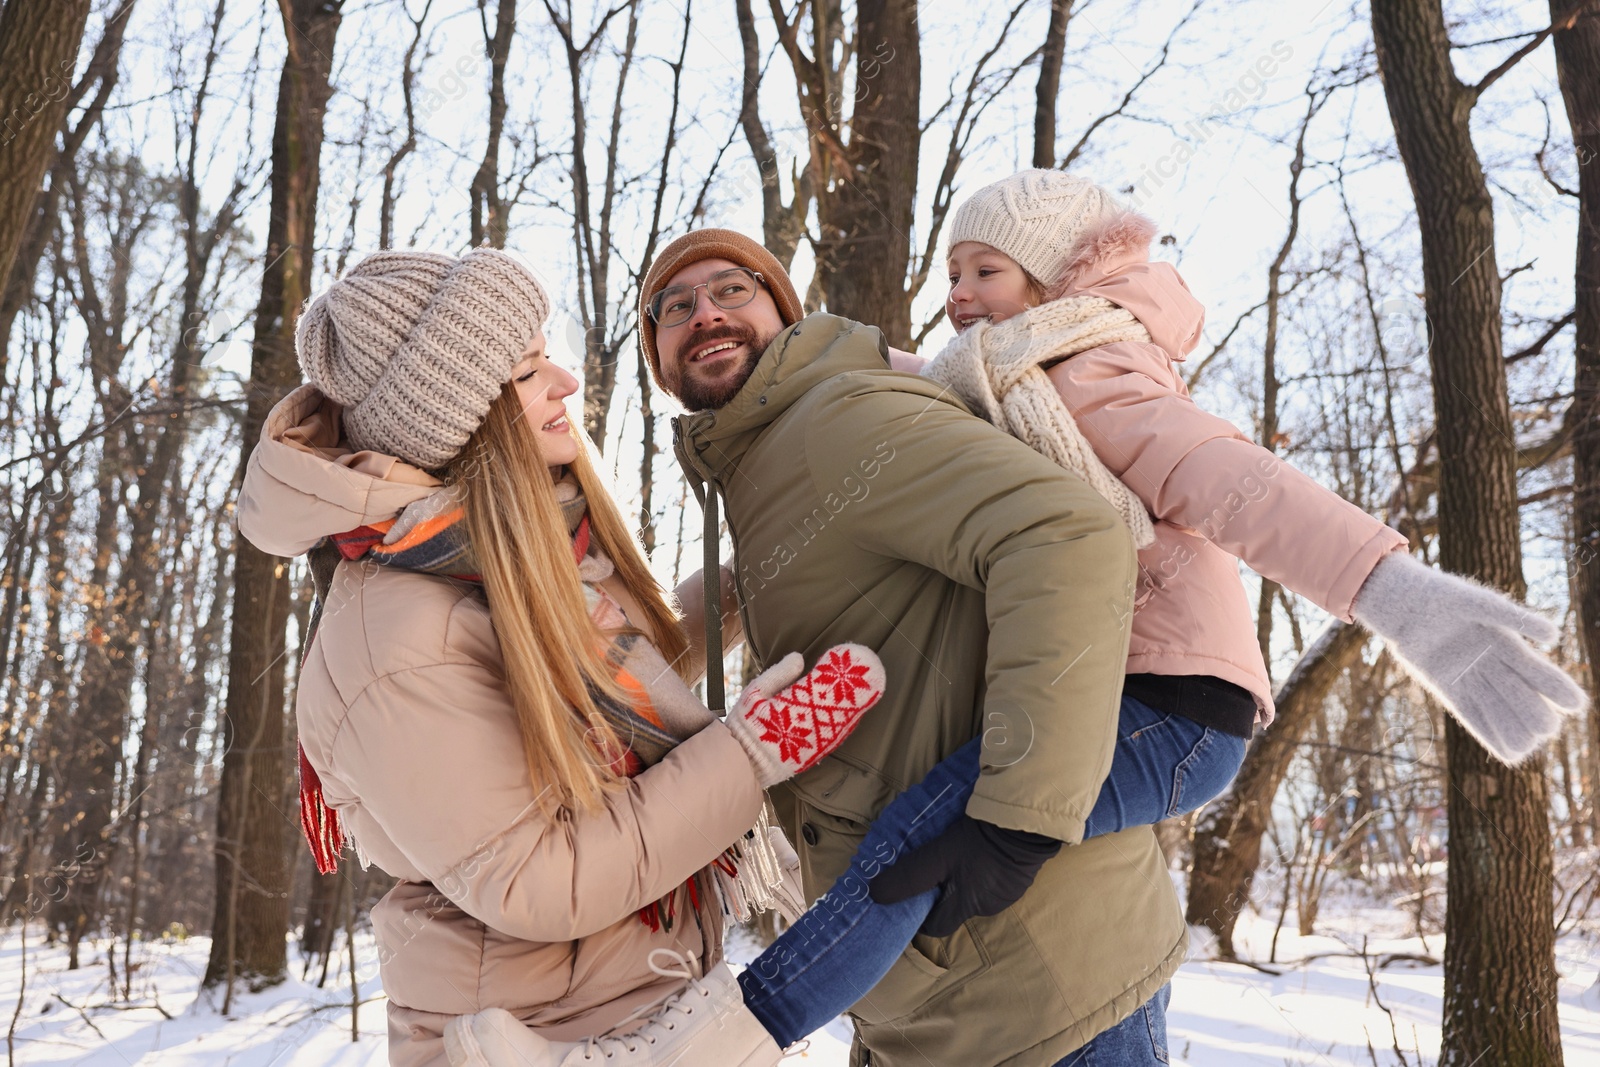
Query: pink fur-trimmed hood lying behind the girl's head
1046,211,1205,362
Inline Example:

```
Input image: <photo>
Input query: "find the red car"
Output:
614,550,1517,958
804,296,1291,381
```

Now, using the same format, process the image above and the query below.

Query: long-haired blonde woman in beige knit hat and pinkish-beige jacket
238,250,883,1067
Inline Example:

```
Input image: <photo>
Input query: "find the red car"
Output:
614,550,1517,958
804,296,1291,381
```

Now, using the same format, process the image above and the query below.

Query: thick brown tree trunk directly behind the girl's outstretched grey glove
1373,0,1562,1067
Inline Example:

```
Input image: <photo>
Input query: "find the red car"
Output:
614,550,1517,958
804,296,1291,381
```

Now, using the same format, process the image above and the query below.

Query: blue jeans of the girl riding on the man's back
739,696,1245,1064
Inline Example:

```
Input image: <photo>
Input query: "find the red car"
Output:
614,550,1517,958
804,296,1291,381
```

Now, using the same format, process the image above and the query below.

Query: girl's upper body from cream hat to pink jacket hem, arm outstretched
896,170,1586,771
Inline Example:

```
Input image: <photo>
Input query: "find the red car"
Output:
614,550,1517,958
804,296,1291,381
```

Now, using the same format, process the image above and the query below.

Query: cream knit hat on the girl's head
949,170,1126,288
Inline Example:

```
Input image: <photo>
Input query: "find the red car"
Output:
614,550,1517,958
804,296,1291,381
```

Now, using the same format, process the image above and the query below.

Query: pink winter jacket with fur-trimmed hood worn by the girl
894,248,1406,726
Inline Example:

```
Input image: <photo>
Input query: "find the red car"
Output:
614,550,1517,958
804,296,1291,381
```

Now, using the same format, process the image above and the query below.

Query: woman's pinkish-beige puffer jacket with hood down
238,386,762,1065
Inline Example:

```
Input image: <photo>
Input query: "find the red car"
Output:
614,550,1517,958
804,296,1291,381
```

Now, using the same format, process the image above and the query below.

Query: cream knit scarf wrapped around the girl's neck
923,296,1155,549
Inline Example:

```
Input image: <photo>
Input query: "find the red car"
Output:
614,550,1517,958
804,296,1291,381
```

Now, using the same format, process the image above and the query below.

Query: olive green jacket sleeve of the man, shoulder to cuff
806,376,1134,843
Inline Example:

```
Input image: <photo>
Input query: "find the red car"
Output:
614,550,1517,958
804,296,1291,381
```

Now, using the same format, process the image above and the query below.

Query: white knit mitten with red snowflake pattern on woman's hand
728,645,883,789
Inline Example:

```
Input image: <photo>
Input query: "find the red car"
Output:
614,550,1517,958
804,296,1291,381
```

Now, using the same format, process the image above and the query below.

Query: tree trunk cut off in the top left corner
0,0,91,381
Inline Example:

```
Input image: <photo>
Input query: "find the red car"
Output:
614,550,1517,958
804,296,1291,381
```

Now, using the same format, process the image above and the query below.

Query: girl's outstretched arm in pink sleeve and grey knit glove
1050,344,1586,763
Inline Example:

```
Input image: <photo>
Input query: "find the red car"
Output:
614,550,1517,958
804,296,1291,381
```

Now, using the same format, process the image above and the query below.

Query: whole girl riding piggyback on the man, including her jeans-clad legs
444,171,1584,1065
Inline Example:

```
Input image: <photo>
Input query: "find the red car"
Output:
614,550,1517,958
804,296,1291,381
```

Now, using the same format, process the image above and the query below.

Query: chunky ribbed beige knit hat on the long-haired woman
294,248,550,470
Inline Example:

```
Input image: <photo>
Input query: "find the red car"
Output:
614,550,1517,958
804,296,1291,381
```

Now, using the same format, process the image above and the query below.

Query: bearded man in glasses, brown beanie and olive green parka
640,230,1186,1067
